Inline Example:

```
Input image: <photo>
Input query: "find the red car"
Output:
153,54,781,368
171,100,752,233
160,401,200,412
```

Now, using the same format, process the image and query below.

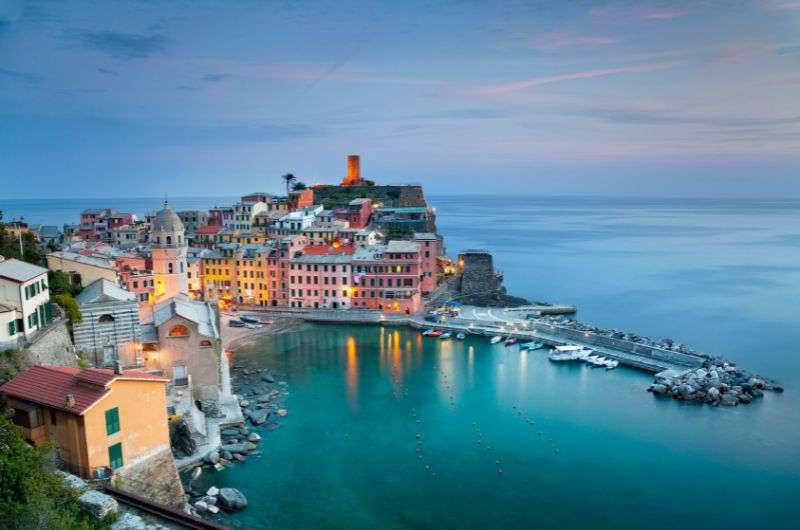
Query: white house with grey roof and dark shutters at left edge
0,259,52,347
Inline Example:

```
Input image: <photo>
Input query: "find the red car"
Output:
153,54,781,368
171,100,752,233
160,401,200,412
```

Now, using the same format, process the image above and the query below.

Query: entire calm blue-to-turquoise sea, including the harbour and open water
0,196,800,530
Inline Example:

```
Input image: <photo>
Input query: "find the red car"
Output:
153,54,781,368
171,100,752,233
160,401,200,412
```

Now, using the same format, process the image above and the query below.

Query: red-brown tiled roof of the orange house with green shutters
0,365,168,415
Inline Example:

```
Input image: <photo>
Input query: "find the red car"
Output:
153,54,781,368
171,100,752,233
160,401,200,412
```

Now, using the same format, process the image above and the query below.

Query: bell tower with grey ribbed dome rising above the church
150,201,189,303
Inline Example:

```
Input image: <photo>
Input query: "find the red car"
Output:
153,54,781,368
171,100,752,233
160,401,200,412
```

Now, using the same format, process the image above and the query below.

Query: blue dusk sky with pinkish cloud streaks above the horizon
0,0,800,199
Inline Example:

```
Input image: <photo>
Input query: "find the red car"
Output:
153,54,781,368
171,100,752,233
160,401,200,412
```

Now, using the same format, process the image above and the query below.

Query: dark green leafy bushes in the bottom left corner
0,414,108,530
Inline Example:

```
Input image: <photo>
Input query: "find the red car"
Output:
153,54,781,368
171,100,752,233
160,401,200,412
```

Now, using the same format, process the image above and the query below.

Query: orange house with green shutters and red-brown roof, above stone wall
0,365,169,478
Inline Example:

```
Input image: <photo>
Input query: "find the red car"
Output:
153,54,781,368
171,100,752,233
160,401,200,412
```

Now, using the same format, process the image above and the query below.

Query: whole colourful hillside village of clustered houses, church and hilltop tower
0,155,466,524
